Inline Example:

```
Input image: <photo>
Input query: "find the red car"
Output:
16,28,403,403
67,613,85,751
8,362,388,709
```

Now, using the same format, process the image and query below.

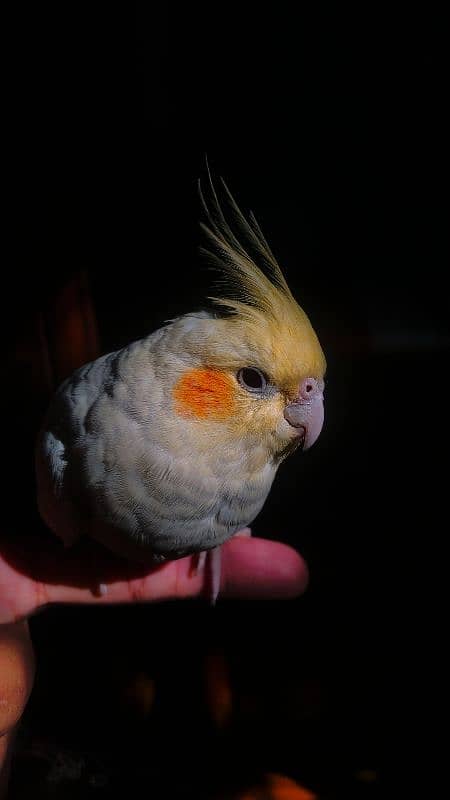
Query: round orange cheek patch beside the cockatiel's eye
173,369,235,420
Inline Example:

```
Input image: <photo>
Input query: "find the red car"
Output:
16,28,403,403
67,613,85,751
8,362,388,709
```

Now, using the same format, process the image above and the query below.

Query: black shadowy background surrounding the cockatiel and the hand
2,3,450,798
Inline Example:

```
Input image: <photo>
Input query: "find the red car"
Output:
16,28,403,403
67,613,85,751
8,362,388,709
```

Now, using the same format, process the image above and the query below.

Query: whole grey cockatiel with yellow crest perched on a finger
36,177,325,601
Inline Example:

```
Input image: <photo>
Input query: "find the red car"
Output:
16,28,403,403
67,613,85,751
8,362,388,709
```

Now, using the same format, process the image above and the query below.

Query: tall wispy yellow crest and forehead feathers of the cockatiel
199,171,325,384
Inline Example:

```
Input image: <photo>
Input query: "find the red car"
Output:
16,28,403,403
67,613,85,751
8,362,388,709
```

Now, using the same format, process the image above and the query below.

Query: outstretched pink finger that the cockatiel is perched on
0,534,308,625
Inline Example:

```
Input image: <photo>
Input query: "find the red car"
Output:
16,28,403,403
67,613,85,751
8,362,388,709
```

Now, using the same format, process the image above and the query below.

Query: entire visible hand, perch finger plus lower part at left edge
0,536,308,798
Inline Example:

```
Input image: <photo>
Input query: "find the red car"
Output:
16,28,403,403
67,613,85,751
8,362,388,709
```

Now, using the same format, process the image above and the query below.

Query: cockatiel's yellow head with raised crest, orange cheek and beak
167,178,326,462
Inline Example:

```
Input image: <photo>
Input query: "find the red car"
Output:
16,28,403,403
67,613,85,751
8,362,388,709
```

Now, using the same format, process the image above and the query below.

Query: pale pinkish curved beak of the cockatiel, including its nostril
284,378,324,450
